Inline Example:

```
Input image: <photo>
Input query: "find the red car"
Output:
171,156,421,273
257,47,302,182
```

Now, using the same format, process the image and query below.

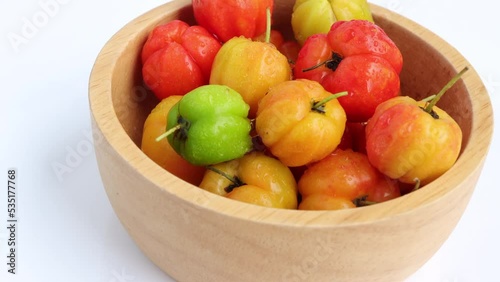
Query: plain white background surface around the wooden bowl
0,0,500,282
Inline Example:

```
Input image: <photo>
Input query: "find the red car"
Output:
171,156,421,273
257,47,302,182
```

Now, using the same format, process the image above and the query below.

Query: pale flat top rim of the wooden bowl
89,0,493,228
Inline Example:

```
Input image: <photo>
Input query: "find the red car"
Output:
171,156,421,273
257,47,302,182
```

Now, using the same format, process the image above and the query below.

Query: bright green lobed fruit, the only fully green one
167,85,252,165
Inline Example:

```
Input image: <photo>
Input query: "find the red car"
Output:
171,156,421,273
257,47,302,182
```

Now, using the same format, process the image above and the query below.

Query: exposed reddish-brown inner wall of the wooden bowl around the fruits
111,3,472,154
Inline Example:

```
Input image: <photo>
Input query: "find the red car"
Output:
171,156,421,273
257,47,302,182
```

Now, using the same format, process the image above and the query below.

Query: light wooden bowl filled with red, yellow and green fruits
89,0,493,281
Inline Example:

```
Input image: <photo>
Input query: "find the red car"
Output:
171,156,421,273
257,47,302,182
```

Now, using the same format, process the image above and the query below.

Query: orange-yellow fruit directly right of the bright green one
255,79,346,166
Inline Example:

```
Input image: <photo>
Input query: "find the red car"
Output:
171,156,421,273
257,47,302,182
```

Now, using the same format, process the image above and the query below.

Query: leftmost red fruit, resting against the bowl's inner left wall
141,20,221,100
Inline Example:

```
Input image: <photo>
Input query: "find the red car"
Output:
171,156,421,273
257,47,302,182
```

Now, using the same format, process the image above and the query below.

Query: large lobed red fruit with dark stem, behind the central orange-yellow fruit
294,20,402,122
